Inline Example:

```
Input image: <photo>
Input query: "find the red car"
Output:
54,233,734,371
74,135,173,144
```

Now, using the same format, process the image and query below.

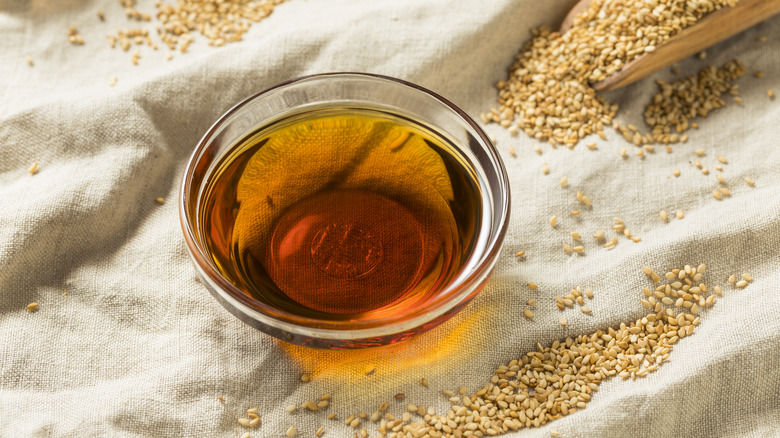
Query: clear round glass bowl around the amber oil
179,73,509,349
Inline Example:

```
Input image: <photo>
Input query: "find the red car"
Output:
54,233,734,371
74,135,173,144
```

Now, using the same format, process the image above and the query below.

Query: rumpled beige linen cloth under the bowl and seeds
0,0,780,437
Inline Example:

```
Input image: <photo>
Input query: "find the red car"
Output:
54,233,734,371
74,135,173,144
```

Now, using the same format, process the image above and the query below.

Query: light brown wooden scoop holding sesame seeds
561,0,780,92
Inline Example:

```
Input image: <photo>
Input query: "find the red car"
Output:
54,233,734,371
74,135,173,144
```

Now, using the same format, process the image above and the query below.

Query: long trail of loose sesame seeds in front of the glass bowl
230,264,753,438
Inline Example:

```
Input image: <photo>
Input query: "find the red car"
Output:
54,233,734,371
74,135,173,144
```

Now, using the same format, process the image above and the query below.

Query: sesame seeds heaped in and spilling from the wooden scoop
482,0,736,147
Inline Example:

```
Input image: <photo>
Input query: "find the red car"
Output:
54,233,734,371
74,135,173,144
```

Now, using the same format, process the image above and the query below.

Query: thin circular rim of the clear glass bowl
178,71,510,340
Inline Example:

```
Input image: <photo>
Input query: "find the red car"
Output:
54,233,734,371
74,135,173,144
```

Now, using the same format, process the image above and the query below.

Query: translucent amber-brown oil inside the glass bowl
200,108,481,320
